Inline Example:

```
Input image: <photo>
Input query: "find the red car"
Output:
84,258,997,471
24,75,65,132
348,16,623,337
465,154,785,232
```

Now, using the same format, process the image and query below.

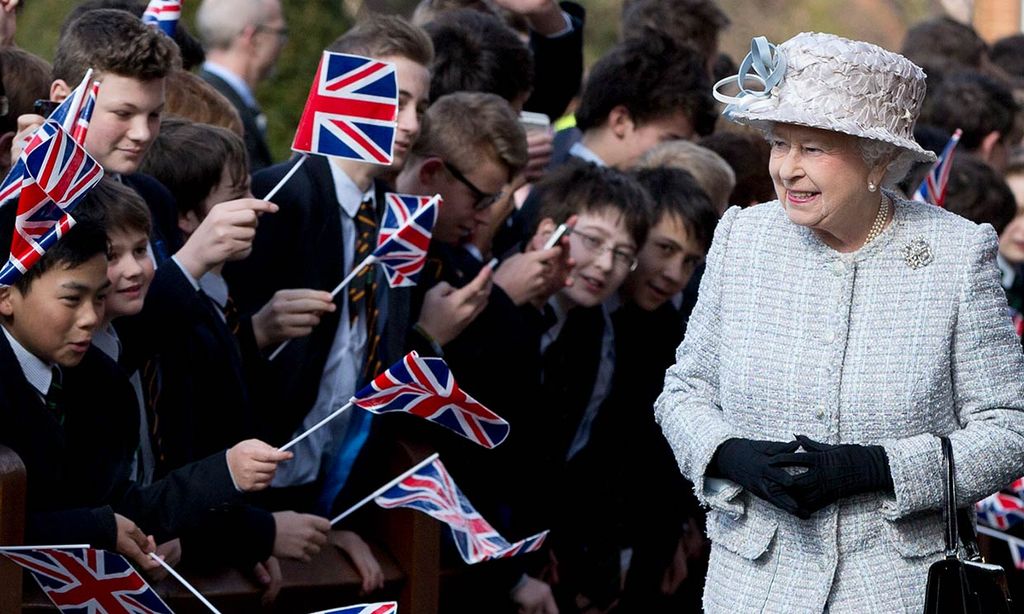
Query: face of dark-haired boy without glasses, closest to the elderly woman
623,213,705,311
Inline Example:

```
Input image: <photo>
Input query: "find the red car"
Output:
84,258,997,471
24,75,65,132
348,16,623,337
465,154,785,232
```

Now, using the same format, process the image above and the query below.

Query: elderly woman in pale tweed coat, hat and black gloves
656,34,1024,612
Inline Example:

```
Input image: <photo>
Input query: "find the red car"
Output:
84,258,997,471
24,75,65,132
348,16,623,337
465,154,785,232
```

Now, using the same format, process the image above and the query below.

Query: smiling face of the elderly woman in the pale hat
768,124,884,247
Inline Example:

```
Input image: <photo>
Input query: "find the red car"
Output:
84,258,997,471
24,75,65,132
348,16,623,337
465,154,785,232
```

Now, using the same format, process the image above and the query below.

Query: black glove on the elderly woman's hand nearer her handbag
771,435,893,518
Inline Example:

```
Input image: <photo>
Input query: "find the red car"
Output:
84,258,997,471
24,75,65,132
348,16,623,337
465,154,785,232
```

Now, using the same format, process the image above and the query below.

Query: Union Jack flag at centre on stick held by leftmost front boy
351,352,509,448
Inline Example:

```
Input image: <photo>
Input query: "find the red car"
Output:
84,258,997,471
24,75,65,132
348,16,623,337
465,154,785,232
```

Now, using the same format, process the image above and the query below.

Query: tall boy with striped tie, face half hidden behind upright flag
225,15,433,513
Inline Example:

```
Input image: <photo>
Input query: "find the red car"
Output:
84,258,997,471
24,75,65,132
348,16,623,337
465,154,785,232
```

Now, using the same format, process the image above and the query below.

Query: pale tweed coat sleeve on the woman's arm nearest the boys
654,207,743,515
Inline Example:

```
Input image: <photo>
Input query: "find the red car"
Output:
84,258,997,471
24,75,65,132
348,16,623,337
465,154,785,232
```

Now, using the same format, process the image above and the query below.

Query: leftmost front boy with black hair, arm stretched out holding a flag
0,208,291,569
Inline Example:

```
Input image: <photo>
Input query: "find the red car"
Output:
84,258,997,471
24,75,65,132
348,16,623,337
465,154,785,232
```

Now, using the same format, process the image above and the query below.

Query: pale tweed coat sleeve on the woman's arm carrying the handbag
882,224,1024,520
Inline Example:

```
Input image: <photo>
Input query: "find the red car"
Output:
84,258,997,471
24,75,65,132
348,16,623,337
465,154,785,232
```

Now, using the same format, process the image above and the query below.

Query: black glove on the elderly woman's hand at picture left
709,439,805,516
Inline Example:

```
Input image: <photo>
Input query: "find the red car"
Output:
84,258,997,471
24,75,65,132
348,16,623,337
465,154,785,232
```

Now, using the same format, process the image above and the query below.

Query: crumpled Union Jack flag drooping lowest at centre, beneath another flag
374,458,548,565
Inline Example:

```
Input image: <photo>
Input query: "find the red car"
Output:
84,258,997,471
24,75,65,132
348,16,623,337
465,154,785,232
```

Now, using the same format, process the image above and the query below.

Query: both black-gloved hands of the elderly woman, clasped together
709,435,893,519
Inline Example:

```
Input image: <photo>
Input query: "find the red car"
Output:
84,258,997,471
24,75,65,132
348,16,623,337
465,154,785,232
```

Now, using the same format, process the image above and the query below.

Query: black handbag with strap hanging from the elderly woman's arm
925,437,1013,614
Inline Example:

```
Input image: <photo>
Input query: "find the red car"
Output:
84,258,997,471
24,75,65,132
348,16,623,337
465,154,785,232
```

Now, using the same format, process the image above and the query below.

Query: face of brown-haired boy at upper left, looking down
85,74,164,175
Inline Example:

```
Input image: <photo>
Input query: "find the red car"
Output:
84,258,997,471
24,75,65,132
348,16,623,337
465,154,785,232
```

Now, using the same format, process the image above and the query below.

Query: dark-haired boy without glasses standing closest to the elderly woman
577,167,718,612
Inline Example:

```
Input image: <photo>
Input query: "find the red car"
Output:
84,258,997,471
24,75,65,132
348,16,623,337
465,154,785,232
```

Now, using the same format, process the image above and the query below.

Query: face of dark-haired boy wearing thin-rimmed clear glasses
559,207,637,307
